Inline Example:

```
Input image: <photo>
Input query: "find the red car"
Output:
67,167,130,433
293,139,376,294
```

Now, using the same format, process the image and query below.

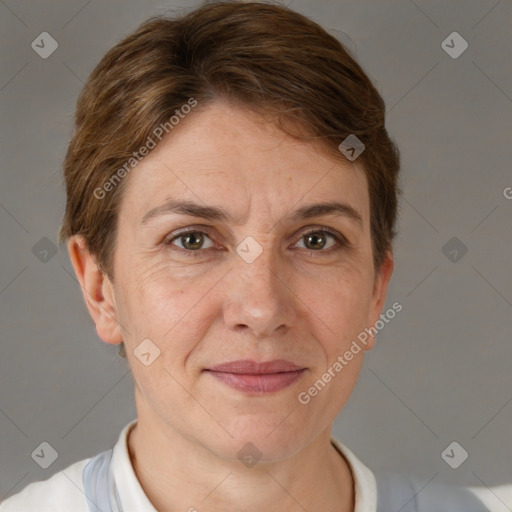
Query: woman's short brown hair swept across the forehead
60,1,400,279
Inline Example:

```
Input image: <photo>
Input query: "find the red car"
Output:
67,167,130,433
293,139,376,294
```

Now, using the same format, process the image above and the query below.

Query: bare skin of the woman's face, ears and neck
68,102,393,512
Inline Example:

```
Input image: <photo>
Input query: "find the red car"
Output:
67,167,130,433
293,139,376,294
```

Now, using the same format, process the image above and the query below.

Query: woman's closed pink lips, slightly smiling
207,359,305,393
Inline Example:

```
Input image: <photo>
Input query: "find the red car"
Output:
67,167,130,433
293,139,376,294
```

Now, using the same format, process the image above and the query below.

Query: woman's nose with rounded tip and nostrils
223,244,297,338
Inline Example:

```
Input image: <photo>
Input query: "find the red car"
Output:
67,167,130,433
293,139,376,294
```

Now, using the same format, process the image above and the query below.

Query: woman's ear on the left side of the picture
67,235,123,345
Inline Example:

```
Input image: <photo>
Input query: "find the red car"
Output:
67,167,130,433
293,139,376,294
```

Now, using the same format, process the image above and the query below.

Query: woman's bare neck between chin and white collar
128,410,355,512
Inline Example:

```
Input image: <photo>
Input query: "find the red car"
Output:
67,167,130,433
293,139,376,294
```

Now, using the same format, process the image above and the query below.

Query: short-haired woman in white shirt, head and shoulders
1,2,492,512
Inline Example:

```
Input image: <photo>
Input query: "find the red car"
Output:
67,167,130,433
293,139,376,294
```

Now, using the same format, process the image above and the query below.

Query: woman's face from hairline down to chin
102,103,392,460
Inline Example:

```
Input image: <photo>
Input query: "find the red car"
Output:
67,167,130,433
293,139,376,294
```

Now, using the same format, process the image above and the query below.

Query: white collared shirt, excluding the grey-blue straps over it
0,420,508,512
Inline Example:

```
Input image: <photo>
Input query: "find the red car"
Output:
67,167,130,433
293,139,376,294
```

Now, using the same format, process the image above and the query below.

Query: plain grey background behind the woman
0,0,512,507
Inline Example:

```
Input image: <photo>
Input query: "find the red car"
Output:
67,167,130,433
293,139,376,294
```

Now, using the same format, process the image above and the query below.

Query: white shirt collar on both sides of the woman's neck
109,420,377,512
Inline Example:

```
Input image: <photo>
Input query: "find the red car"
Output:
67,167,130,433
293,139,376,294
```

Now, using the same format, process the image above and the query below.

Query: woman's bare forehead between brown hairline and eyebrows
121,103,369,224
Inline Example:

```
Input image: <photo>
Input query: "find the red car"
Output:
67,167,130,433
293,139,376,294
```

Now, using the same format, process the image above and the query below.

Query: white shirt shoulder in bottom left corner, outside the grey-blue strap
0,458,91,512
